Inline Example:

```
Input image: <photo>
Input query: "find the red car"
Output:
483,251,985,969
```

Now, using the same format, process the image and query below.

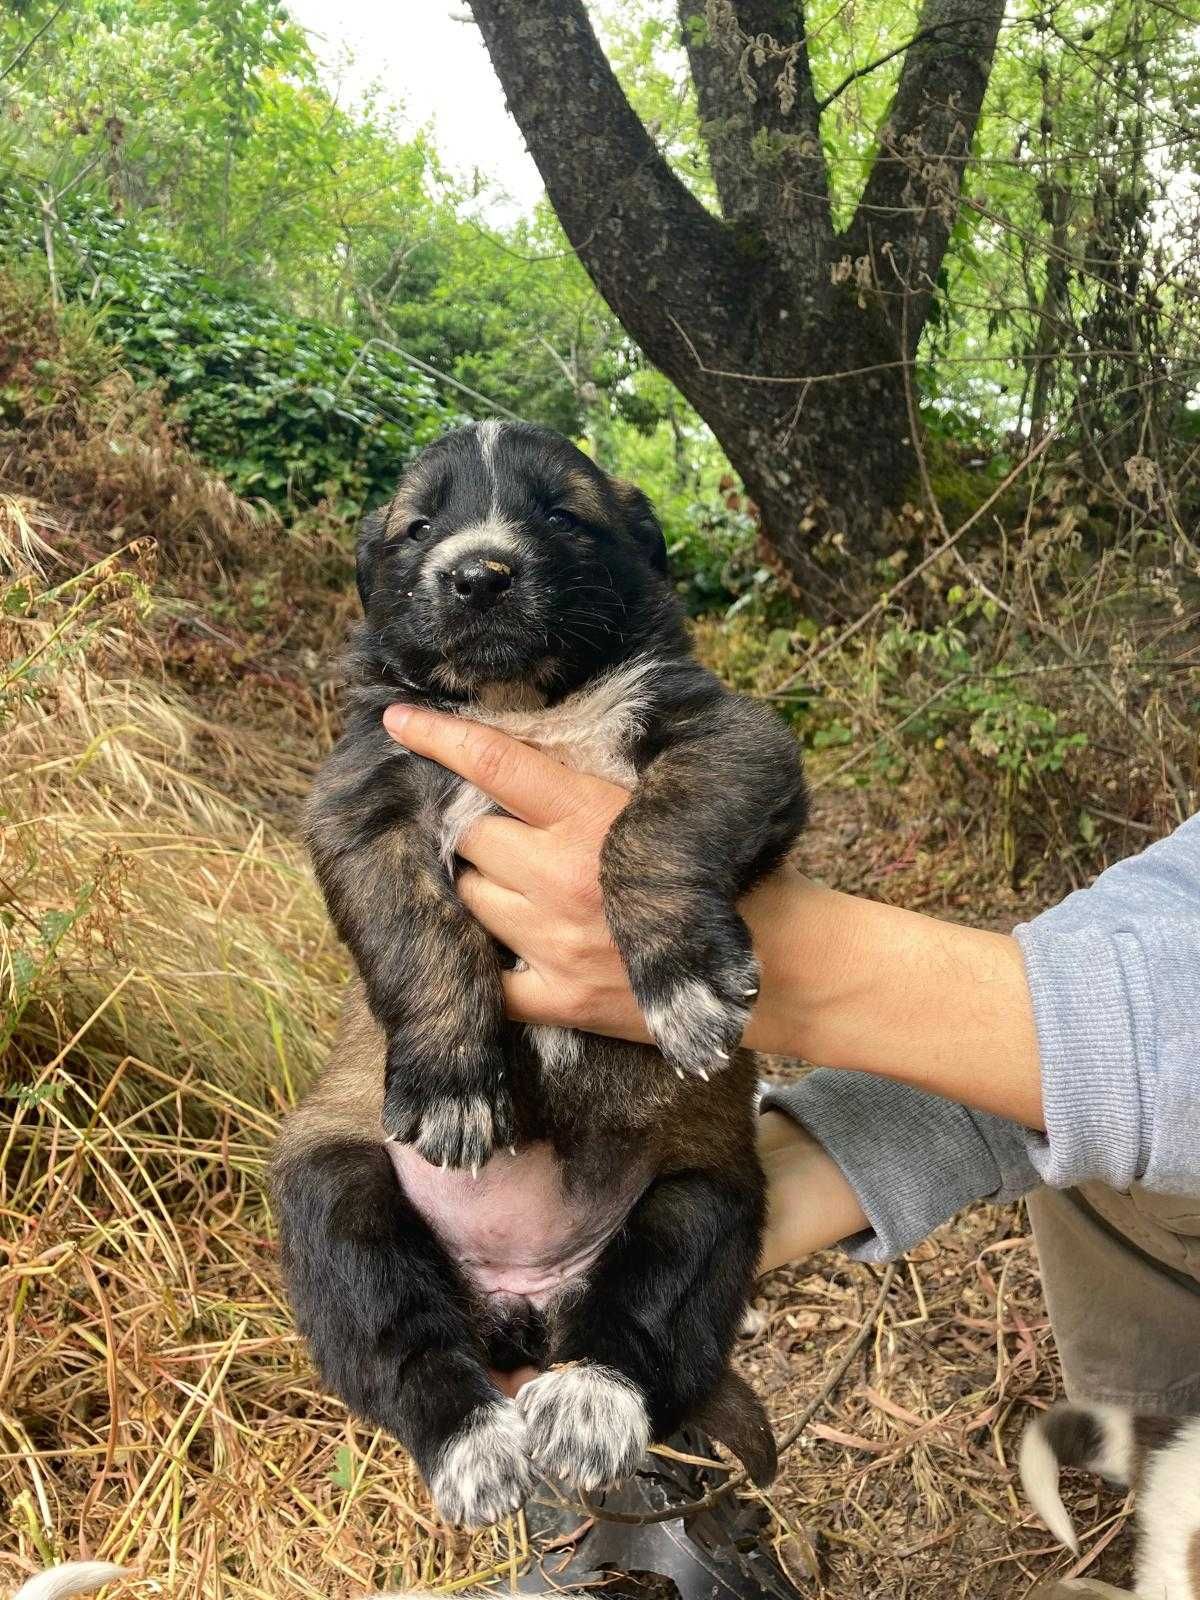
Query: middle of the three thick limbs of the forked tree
678,0,832,274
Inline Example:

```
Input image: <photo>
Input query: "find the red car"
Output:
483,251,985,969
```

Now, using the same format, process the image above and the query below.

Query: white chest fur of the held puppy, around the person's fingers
440,656,654,870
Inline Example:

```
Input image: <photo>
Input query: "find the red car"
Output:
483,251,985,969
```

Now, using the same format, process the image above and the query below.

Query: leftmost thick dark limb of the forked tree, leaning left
470,0,754,390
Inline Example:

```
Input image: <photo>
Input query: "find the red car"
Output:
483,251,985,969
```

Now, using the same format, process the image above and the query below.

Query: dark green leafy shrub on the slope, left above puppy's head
0,187,456,510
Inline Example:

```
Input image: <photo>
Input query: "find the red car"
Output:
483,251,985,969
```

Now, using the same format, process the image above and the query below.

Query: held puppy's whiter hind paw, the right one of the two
517,1362,650,1491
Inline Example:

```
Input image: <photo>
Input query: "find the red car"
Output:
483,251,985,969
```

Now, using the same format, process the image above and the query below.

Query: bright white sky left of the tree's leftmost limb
288,0,542,213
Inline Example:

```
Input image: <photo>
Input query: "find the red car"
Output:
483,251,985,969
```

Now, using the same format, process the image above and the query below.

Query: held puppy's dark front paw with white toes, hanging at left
382,1061,514,1170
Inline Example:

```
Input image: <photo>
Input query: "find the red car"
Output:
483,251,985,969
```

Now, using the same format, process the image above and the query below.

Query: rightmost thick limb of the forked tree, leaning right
843,0,1005,354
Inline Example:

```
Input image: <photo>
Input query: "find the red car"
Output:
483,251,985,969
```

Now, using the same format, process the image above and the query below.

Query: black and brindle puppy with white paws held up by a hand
274,422,805,1523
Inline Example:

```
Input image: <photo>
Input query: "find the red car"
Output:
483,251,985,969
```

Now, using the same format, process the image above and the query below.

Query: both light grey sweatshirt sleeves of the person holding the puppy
763,816,1200,1261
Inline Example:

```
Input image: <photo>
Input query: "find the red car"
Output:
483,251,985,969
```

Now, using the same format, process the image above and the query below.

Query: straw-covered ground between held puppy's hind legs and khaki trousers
742,1206,1128,1600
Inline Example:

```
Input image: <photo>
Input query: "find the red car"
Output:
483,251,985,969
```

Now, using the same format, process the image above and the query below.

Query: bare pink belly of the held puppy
387,1142,650,1306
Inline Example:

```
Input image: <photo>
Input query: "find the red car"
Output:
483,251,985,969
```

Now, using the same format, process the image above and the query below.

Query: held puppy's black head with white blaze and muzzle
358,422,672,694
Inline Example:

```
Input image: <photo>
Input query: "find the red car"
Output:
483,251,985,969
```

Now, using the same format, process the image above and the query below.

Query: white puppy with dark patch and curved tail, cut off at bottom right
1021,1403,1200,1600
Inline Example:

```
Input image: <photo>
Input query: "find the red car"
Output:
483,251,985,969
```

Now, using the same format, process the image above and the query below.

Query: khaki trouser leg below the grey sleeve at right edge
1029,1184,1200,1414
